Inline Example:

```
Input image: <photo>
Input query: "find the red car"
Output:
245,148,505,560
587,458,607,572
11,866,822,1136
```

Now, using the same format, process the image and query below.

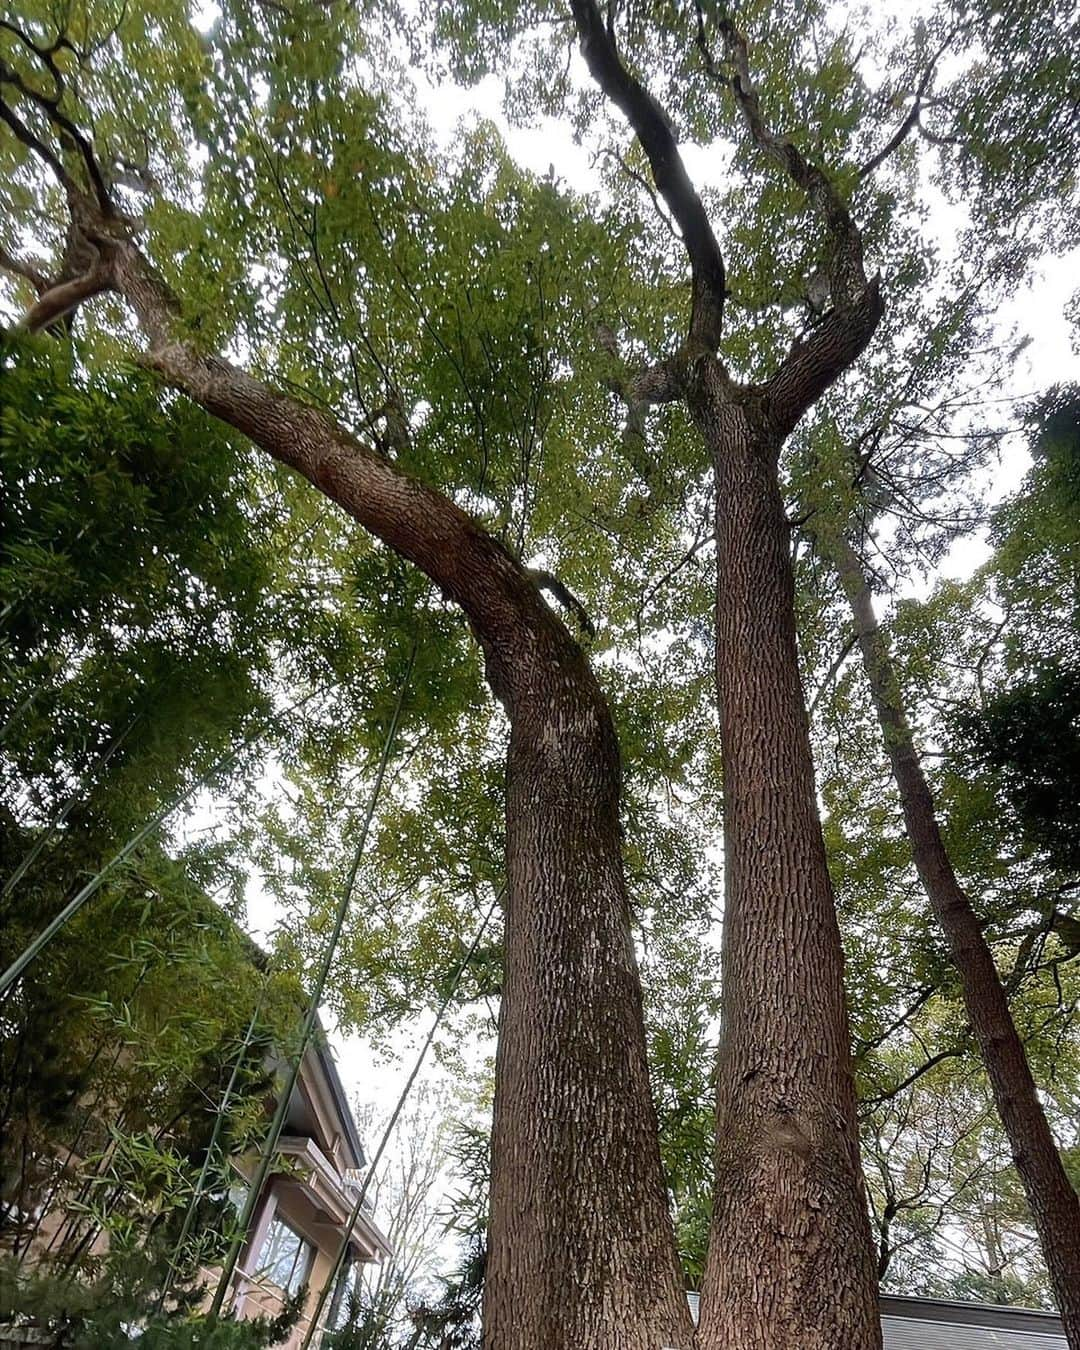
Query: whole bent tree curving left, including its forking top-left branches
0,7,691,1350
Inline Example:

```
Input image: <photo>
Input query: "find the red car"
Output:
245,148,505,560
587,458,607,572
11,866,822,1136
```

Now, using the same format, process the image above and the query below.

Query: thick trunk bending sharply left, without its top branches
88,234,693,1350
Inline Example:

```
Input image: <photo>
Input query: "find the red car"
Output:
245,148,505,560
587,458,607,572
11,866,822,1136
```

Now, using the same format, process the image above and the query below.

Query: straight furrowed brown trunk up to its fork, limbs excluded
694,378,882,1350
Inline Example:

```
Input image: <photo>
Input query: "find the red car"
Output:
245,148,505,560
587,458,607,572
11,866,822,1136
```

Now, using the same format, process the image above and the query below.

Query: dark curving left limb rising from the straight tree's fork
570,0,725,352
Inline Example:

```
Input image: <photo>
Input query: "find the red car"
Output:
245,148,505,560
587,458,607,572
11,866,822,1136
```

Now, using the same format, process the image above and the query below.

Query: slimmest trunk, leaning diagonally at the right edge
815,536,1080,1350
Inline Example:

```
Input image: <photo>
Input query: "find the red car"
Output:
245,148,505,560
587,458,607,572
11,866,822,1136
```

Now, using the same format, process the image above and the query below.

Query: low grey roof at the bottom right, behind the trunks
687,1293,1068,1350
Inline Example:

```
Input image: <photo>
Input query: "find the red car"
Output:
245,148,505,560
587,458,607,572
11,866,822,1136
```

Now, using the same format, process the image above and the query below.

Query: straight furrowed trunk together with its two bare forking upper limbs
523,0,882,1347
